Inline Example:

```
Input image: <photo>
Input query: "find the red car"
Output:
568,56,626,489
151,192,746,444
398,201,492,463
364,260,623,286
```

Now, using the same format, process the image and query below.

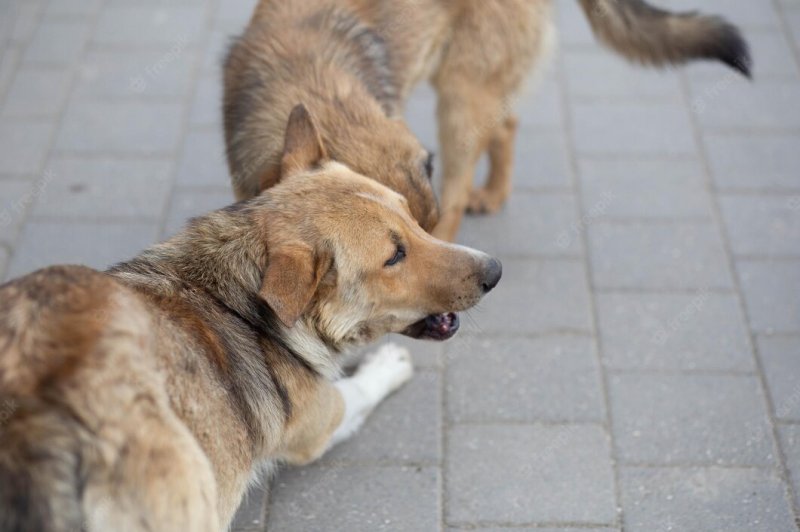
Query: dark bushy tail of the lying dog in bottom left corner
0,396,85,532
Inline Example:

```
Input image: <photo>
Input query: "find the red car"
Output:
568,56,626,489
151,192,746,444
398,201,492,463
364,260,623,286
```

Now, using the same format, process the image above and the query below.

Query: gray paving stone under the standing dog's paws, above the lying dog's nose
459,190,582,258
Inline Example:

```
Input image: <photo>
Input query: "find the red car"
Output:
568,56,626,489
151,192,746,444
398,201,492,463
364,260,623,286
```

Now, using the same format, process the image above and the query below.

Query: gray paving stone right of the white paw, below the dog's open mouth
446,336,606,423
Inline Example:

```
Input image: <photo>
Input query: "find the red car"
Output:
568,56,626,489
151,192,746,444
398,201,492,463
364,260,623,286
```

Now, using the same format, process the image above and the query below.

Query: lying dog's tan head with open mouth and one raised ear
261,107,501,348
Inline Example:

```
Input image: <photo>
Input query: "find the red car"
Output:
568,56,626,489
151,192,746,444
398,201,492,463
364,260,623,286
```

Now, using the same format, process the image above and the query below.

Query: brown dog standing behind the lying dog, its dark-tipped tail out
224,0,750,240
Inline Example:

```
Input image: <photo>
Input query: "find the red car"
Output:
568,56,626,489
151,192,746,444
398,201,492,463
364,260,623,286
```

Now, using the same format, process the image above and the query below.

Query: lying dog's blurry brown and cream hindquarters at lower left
0,266,218,532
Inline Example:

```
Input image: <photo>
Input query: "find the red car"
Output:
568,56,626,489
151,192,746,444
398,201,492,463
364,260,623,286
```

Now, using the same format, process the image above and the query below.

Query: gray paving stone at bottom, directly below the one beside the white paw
445,425,617,525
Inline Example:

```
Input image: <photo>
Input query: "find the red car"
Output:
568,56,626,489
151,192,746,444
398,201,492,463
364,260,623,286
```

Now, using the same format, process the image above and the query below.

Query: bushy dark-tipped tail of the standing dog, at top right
580,0,751,77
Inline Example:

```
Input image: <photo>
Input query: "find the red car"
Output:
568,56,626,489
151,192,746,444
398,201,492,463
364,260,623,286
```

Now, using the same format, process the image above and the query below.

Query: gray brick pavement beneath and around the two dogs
0,0,800,532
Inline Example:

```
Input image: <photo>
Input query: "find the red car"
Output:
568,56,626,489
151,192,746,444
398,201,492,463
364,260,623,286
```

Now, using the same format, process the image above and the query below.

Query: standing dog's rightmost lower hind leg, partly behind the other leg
467,116,517,214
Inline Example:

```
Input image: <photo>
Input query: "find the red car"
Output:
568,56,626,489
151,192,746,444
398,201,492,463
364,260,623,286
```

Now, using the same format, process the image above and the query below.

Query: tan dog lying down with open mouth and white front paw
0,108,501,532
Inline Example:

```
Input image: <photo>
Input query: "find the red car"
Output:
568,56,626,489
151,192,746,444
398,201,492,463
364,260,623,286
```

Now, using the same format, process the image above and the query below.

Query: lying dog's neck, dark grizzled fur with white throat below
109,202,341,379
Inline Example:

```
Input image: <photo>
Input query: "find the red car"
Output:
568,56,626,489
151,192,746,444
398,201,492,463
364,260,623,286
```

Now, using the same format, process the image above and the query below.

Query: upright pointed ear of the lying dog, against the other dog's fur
281,104,328,178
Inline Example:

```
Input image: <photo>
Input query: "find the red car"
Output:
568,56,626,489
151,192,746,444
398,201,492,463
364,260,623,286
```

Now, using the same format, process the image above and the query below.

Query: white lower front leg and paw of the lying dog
329,344,414,447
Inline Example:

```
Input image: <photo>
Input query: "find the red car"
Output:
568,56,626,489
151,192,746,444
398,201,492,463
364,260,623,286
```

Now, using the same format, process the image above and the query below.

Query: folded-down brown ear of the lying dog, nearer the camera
260,243,330,327
